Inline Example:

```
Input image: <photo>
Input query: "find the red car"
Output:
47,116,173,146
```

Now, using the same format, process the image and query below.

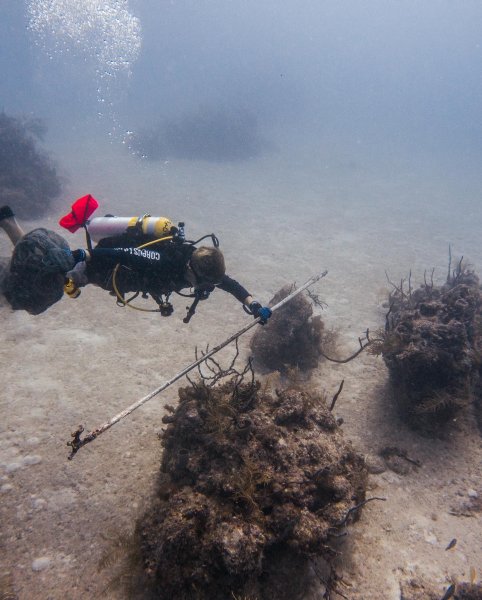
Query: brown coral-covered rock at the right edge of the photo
381,268,482,433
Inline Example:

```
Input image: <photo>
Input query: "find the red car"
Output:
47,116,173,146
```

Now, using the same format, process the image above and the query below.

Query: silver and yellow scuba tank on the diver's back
86,215,173,242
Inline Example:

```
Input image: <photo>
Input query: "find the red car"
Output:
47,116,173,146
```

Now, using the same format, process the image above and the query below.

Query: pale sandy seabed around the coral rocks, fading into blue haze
0,129,482,600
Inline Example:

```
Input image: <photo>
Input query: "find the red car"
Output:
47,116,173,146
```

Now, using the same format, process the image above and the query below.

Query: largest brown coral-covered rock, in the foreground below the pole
138,381,367,600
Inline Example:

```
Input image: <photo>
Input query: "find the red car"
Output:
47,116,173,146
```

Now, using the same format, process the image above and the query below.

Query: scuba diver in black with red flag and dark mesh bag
0,194,271,324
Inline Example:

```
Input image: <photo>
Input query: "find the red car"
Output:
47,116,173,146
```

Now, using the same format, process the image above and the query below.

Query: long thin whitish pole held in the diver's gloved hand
67,271,328,460
